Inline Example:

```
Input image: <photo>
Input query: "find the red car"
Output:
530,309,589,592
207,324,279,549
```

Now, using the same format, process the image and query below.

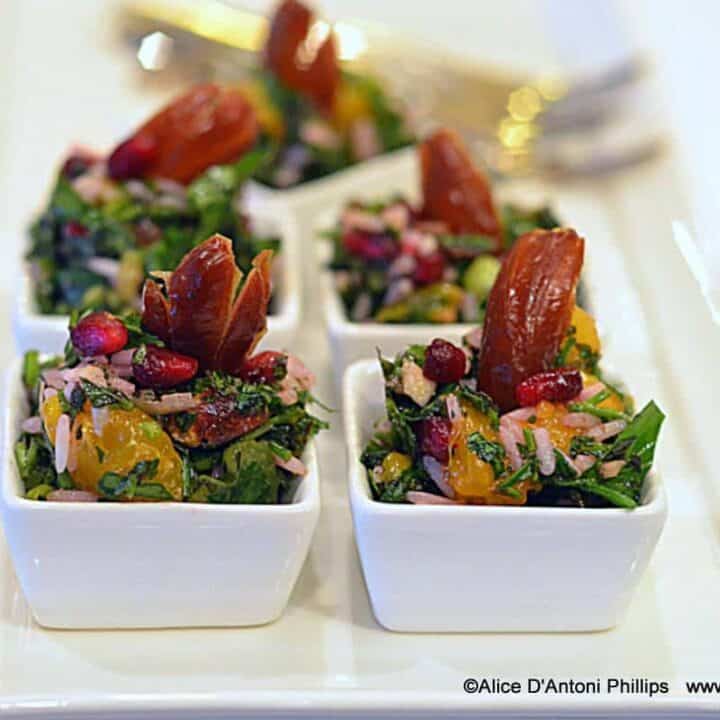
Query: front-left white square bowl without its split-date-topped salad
0,362,320,629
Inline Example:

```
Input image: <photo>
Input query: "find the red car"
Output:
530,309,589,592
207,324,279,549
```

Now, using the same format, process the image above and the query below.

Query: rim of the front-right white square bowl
342,360,667,522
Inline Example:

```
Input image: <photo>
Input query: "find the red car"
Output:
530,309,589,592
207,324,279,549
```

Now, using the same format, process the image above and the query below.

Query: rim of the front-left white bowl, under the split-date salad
0,357,320,522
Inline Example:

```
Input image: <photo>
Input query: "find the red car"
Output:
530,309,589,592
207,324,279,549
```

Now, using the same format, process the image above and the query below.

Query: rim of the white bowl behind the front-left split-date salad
14,207,302,332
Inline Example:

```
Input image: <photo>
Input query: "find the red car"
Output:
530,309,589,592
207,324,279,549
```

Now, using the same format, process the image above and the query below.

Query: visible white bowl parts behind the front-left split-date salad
13,208,302,353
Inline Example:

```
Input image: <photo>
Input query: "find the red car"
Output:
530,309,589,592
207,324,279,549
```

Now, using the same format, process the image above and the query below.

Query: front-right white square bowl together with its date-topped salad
344,228,667,632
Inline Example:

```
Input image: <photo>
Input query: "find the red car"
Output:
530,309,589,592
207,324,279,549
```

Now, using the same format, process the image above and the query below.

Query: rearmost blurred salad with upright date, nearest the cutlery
242,0,414,188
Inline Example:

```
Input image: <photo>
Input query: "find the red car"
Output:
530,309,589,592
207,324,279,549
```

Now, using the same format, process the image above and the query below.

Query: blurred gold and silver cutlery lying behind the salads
118,0,664,179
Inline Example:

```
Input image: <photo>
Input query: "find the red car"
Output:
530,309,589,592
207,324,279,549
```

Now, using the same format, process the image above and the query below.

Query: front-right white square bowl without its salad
344,360,667,632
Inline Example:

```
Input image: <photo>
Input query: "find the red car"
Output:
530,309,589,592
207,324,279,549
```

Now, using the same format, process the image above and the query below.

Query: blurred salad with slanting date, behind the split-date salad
28,84,280,315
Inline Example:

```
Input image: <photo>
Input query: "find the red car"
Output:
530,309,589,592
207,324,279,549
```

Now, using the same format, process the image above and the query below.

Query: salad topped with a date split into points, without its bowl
15,235,326,504
